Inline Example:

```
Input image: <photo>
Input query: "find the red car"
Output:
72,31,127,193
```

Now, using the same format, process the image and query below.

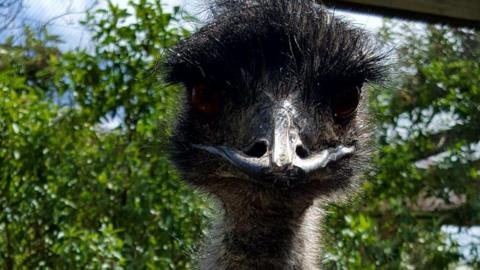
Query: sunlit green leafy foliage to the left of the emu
0,1,207,269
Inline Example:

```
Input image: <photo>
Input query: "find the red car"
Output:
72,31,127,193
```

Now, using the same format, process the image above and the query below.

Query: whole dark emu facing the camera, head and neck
164,0,383,269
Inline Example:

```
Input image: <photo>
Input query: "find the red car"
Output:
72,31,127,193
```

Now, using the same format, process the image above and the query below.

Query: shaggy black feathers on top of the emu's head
166,0,383,97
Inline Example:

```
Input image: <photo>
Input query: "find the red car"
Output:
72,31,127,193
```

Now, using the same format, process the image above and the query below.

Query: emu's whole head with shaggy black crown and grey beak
166,0,381,200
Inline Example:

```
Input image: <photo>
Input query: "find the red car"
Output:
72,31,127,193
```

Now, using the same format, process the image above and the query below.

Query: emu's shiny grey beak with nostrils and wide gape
192,99,355,186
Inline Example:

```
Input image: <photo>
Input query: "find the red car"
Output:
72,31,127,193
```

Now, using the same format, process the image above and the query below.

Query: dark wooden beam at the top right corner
319,0,480,28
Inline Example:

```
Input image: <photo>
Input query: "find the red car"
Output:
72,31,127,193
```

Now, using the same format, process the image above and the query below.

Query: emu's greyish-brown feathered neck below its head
202,190,321,270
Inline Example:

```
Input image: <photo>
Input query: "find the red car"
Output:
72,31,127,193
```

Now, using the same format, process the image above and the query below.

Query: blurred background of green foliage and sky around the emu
0,0,480,269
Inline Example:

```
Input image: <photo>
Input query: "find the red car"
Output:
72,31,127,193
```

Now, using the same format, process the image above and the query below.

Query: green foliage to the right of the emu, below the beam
325,24,480,269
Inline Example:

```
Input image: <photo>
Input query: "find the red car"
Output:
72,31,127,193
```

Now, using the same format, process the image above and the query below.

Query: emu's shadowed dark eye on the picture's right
331,87,361,124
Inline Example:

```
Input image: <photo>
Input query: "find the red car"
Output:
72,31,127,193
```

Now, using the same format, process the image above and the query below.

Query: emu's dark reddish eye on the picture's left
191,83,220,115
